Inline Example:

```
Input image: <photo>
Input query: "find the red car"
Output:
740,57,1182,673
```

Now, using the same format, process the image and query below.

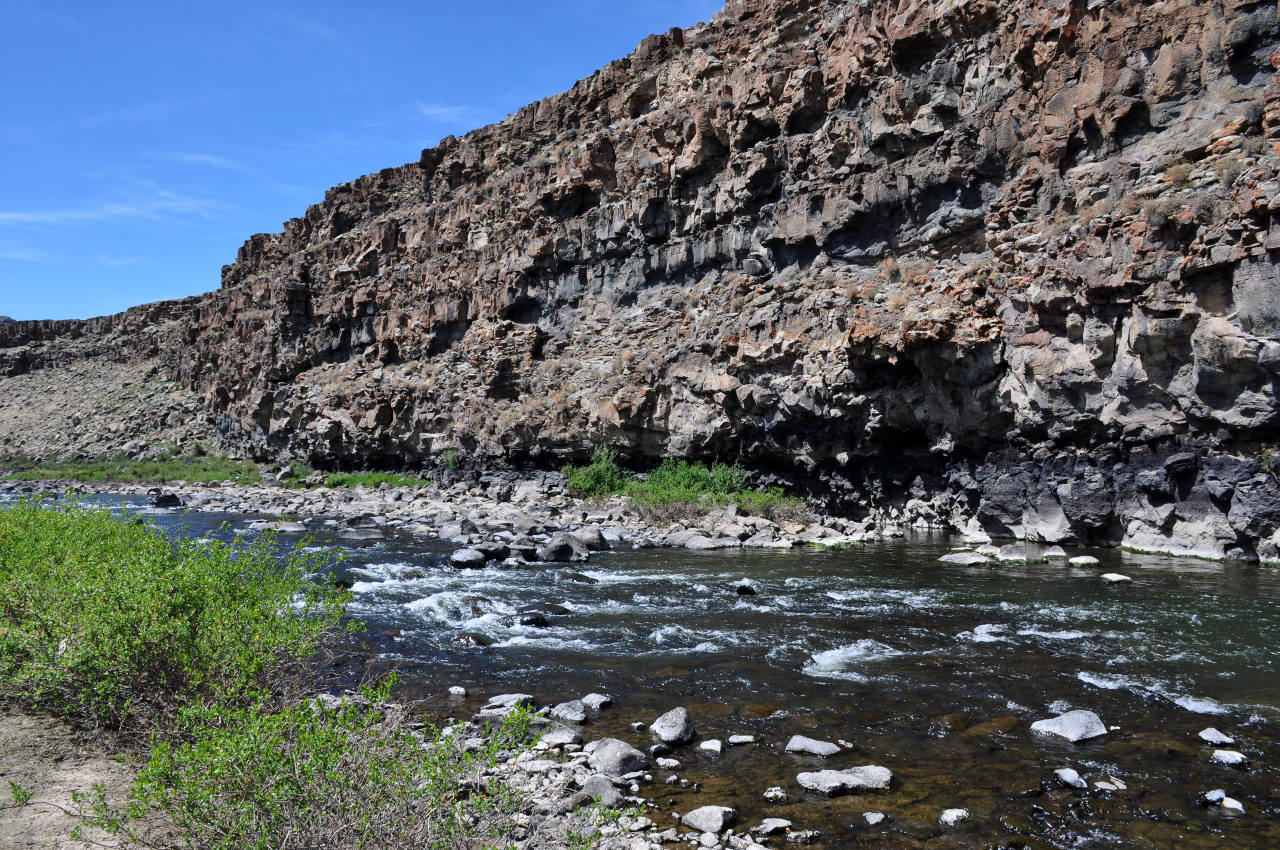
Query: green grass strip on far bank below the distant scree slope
3,453,262,484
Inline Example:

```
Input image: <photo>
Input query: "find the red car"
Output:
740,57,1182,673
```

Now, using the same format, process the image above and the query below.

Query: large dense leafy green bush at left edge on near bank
0,502,346,726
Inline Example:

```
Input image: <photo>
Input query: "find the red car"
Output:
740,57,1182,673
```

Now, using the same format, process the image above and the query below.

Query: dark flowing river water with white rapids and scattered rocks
20,491,1280,849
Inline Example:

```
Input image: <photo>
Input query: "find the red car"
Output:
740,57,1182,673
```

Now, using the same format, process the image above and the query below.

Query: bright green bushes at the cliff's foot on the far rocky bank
562,447,808,521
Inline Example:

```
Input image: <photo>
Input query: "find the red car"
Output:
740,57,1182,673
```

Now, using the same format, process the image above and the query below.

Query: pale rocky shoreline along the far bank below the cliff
0,472,1280,566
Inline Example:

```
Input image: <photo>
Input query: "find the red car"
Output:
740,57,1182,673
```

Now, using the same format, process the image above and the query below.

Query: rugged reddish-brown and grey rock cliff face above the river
0,0,1280,558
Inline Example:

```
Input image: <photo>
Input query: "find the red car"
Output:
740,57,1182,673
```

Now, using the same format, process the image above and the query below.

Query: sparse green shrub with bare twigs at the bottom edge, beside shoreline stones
108,684,532,850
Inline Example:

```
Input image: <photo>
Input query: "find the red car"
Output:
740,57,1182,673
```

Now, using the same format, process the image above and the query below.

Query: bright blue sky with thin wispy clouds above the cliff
0,0,723,319
